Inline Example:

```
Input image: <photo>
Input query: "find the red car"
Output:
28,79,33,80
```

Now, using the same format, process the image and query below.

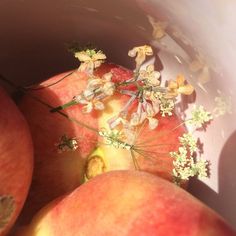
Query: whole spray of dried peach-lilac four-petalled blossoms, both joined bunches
53,45,194,131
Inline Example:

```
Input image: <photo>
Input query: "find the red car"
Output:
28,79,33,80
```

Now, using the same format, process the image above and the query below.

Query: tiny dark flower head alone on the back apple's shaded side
55,135,78,153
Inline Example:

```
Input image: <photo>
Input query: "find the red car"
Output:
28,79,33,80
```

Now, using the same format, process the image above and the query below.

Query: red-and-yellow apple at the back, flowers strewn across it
16,63,185,223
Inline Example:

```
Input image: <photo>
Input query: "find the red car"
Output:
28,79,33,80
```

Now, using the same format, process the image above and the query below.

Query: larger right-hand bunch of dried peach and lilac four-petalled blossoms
106,45,194,129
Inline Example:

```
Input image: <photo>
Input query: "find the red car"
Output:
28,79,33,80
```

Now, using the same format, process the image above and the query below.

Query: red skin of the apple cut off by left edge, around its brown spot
0,88,33,236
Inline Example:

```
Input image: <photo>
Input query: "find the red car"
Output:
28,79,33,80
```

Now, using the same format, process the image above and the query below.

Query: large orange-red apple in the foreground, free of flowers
15,170,236,236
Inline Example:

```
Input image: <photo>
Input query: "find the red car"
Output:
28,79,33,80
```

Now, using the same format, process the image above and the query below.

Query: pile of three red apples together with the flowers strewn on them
0,45,235,236
